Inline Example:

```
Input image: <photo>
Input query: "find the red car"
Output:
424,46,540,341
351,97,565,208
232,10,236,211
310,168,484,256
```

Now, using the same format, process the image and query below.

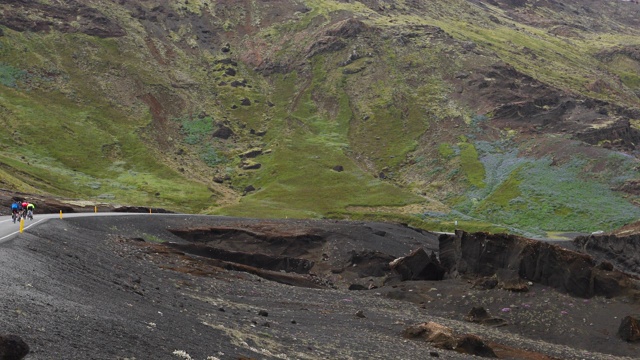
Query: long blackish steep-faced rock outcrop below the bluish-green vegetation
439,231,638,298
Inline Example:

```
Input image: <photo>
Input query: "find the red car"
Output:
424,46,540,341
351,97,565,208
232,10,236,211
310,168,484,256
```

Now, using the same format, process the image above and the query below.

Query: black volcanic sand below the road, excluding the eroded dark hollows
0,215,640,360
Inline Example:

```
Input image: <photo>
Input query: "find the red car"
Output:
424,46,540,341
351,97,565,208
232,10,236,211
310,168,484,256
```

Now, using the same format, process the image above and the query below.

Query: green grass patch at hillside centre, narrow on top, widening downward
220,62,421,217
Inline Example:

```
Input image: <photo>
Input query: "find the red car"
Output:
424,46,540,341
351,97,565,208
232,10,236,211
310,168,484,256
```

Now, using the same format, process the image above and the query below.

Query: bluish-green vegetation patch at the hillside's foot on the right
462,143,640,234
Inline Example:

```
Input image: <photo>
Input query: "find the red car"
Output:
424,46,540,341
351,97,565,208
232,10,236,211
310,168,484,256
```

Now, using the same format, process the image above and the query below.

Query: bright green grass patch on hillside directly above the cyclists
0,82,212,211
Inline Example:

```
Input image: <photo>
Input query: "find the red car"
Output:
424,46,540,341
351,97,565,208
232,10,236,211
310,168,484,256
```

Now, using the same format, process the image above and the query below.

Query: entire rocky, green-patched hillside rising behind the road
0,0,640,237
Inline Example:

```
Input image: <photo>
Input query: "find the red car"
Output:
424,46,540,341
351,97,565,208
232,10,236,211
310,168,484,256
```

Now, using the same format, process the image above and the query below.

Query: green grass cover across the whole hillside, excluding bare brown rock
0,0,640,232
